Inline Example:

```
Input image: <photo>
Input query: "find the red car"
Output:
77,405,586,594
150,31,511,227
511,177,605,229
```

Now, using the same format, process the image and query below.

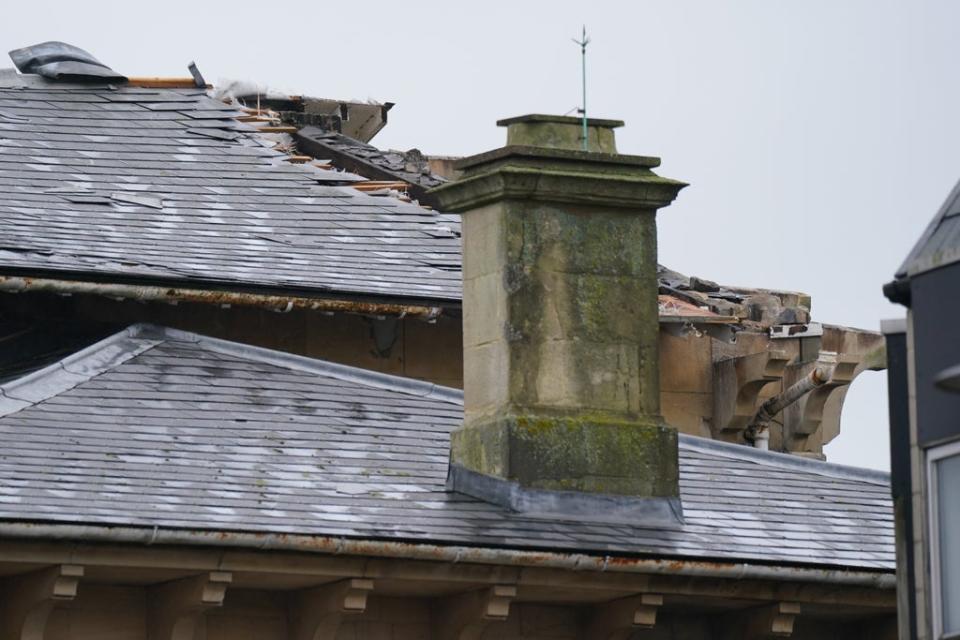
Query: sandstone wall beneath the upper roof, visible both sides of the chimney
0,294,885,456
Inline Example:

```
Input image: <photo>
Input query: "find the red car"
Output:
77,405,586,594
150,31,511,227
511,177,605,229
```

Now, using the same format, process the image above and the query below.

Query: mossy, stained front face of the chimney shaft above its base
500,203,659,415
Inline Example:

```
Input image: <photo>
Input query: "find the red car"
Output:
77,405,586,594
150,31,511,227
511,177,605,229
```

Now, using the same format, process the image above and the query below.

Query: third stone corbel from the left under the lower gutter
290,578,373,640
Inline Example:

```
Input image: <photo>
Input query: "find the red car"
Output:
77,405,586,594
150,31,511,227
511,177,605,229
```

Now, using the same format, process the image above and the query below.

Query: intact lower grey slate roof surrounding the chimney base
0,325,894,570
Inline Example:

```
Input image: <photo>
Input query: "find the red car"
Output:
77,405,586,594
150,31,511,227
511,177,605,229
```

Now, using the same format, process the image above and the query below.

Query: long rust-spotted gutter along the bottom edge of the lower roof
0,522,896,589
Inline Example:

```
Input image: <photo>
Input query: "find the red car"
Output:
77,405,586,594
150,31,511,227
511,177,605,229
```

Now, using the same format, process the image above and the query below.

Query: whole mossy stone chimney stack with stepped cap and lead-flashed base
432,115,685,525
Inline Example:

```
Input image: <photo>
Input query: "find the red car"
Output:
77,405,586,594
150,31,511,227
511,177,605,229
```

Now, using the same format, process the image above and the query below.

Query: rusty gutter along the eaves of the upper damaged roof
0,275,443,320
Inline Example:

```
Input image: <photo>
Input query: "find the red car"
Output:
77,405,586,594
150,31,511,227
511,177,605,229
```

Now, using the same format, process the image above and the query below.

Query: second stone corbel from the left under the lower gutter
147,571,233,640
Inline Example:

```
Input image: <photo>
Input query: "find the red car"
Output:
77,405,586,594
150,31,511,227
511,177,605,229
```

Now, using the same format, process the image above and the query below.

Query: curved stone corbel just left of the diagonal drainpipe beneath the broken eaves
713,349,794,433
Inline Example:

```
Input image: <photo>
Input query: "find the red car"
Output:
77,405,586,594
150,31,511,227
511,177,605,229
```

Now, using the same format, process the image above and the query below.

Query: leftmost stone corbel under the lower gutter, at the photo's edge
0,564,83,640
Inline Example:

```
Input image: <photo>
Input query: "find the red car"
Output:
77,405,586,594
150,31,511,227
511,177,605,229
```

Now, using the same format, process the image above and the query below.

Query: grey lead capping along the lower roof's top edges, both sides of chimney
0,323,890,486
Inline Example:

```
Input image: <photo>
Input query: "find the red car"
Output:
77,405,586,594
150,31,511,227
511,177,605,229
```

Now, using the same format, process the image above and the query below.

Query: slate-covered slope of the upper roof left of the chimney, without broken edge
0,71,460,300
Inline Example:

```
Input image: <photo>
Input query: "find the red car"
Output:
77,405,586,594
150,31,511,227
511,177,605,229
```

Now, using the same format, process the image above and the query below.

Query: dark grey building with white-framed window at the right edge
884,179,960,640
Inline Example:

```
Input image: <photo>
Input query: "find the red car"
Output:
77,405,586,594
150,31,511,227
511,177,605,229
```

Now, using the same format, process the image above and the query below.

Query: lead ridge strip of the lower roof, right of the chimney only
679,433,890,486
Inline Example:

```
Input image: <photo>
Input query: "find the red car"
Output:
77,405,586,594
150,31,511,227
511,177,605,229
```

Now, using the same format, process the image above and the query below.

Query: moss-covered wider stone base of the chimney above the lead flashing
451,415,679,497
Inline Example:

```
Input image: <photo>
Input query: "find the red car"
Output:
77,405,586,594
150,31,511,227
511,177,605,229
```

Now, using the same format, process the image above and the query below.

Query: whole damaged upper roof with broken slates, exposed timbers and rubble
0,43,809,322
